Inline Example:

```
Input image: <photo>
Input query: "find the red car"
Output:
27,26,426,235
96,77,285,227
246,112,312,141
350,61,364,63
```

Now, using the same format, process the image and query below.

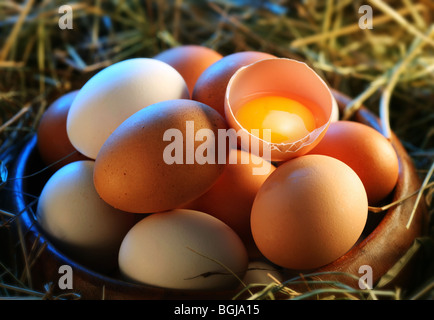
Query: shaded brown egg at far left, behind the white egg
37,90,87,170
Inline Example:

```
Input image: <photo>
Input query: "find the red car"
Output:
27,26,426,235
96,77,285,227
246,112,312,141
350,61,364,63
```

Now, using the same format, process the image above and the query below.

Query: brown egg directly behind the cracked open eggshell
192,51,275,117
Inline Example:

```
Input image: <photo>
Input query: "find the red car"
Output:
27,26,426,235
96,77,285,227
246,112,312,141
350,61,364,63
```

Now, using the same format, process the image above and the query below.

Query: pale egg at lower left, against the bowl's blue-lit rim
36,160,136,273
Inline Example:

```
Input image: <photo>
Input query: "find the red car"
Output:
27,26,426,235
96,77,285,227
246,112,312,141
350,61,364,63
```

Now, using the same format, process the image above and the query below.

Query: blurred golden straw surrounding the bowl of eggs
0,0,434,299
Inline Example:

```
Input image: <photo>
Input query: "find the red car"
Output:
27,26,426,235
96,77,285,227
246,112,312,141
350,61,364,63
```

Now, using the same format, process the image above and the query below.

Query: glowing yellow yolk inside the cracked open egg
235,96,315,143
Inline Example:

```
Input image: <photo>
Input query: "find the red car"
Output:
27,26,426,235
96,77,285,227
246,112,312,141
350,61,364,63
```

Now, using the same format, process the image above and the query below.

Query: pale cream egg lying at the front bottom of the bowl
119,209,248,290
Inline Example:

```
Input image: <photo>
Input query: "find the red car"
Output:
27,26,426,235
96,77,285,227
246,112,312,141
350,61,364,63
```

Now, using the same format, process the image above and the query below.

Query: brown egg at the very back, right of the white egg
154,45,223,95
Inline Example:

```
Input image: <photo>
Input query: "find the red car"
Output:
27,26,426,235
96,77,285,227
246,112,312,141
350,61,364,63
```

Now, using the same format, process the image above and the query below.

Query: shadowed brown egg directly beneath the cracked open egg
183,149,275,257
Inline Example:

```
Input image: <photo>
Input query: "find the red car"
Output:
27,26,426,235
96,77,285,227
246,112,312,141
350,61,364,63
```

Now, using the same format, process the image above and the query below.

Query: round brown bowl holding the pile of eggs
4,91,427,300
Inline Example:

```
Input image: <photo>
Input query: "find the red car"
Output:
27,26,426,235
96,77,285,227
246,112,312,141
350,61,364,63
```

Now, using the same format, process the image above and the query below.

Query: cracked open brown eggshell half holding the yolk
224,58,338,162
